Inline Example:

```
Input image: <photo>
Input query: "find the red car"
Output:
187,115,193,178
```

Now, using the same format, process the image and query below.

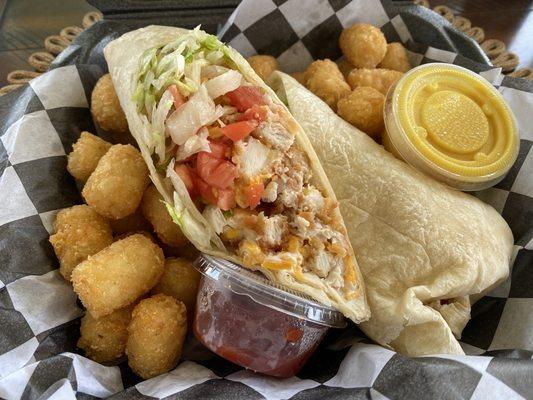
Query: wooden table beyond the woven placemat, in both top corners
0,0,533,86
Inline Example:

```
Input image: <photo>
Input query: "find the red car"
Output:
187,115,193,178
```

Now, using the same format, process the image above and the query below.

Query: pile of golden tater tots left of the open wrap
50,75,200,379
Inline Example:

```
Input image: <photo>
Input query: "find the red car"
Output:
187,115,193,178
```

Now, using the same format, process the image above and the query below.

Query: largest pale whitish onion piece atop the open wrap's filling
166,85,223,145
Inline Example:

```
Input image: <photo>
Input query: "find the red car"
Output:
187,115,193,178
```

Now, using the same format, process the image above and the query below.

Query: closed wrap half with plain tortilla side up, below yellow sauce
269,73,513,356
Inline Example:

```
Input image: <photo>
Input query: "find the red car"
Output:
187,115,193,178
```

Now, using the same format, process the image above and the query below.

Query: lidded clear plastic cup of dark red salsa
193,255,346,377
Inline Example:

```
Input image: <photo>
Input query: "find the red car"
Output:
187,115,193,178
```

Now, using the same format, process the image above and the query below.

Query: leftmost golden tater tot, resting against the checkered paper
50,204,113,281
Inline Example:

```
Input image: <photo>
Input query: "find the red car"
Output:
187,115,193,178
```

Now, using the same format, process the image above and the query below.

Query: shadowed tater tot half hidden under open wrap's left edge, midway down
141,185,188,247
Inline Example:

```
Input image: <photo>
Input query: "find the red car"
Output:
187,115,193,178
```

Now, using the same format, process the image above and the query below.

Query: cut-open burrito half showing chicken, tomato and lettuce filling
104,26,370,323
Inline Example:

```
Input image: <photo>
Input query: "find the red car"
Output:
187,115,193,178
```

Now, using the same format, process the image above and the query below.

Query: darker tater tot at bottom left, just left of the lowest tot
78,306,133,363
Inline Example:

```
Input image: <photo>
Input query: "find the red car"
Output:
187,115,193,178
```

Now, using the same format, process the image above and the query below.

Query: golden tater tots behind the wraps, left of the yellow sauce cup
248,24,411,141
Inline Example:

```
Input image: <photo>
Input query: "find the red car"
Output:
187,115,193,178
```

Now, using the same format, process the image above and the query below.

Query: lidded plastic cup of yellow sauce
383,63,520,191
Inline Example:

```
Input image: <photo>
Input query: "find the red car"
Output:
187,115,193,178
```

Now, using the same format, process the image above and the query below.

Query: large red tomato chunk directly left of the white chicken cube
196,151,237,189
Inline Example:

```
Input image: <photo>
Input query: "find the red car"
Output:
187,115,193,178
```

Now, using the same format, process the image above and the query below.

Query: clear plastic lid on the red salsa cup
194,254,346,328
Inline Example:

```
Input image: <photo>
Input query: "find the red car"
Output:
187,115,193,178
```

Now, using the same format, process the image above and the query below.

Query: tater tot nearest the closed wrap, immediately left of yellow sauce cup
337,86,385,137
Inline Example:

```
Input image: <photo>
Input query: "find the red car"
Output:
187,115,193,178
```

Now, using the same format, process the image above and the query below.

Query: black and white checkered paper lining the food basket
0,0,533,399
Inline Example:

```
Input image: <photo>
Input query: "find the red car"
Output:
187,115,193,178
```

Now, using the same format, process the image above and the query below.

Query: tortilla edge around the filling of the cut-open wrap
104,26,370,322
